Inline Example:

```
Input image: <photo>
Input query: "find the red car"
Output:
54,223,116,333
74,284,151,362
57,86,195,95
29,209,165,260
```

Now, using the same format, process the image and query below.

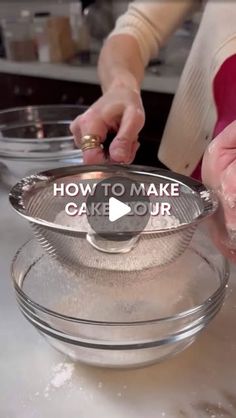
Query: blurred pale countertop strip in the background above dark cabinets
0,59,181,94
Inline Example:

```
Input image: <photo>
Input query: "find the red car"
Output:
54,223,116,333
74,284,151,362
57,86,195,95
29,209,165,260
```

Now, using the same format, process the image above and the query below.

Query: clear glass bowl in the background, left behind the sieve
0,105,86,185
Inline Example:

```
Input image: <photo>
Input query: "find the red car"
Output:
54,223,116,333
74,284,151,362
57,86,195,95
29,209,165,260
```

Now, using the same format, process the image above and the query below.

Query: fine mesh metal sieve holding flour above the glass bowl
10,165,218,272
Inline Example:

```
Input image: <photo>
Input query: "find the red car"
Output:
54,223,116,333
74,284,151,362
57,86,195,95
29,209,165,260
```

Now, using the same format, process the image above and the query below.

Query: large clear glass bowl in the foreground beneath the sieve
12,230,229,368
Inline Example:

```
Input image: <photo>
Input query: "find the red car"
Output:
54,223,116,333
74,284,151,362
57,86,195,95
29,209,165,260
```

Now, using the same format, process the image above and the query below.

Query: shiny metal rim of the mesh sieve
9,164,219,238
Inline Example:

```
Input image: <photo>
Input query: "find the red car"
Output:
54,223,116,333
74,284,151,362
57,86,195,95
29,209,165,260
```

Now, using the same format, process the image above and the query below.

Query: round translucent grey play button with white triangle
86,175,150,237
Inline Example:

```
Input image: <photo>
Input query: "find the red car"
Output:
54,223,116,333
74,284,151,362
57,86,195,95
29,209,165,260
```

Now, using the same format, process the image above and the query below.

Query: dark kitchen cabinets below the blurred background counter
0,73,173,166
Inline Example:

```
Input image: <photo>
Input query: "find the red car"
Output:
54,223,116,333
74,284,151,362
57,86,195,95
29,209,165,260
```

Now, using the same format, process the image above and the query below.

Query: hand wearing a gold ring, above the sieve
70,86,145,164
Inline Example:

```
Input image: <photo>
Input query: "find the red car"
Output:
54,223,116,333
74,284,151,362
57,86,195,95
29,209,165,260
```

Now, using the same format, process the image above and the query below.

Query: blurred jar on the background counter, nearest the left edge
2,10,37,61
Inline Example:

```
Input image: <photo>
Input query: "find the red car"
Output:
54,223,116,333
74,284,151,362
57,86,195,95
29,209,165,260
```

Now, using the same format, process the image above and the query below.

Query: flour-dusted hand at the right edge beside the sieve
202,121,236,262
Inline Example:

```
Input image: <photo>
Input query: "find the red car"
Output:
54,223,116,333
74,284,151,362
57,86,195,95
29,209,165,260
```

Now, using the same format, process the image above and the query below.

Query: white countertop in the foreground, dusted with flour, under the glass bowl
0,175,236,418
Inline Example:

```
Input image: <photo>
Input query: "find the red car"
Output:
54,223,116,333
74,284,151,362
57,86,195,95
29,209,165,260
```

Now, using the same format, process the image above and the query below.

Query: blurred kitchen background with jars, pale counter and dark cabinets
0,0,201,165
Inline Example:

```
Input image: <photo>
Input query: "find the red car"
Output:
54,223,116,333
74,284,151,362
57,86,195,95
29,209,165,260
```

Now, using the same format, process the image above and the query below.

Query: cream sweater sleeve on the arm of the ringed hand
109,0,200,66
